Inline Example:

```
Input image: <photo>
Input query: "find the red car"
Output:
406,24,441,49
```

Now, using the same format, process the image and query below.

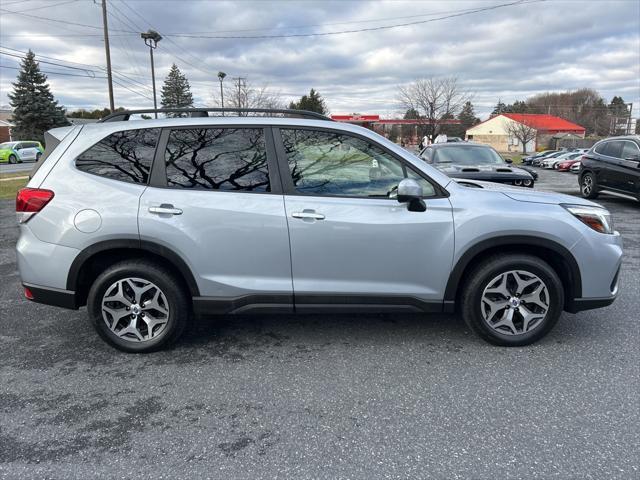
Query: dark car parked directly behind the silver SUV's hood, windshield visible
420,142,535,187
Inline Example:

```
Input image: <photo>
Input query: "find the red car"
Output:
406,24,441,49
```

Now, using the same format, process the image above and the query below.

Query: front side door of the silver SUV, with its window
275,128,454,310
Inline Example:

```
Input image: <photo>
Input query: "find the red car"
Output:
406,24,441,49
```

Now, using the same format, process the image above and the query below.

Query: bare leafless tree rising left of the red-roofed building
398,77,471,140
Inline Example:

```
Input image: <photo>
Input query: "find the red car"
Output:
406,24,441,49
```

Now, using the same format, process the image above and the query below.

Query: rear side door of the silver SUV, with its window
139,126,293,313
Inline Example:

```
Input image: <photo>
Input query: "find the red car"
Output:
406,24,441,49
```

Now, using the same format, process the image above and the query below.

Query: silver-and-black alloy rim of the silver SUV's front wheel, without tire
480,270,549,335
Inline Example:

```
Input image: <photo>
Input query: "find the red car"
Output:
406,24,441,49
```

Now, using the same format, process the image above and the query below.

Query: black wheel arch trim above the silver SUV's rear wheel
67,239,200,306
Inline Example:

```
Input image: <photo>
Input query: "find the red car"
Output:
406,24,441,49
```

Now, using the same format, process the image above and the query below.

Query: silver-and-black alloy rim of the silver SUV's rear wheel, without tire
102,278,169,342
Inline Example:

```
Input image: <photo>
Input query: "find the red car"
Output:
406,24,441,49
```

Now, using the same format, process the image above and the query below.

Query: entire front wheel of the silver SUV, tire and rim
461,254,564,347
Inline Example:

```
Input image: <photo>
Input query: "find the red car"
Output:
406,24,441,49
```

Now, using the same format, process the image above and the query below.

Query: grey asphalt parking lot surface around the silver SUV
0,170,640,479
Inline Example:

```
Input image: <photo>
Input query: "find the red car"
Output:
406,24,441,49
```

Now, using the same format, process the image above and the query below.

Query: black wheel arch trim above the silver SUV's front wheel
444,235,582,308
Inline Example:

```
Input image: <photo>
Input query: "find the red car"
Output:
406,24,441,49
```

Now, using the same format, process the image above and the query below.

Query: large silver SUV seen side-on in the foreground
16,109,622,352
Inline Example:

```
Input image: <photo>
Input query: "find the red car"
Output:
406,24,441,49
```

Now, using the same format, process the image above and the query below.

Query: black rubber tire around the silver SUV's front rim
461,254,564,347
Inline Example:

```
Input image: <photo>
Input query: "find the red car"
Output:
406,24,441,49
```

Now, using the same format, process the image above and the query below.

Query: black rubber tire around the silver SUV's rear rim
87,260,191,353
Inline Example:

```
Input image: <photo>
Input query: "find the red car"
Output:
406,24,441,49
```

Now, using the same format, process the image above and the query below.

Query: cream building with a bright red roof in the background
466,113,586,152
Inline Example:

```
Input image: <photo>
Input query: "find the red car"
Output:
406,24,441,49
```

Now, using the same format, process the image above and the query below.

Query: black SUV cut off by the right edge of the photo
579,135,640,201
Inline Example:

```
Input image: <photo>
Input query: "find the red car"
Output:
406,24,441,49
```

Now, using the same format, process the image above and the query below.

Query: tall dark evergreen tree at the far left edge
9,50,69,142
